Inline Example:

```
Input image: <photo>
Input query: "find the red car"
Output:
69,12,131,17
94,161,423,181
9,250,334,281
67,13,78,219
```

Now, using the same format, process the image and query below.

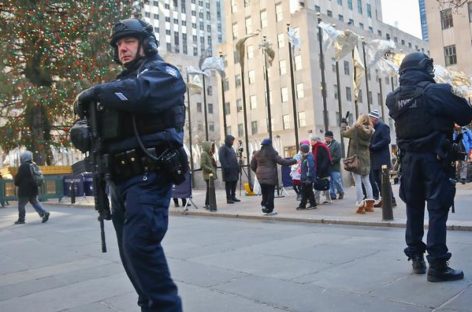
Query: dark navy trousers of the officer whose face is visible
111,172,182,312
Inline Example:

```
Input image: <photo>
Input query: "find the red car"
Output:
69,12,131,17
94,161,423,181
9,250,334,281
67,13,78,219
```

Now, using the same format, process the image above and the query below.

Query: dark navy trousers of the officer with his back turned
400,152,454,263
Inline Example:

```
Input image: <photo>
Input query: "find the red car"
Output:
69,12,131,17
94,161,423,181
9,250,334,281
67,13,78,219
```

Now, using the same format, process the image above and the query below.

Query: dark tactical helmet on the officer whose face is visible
110,18,159,63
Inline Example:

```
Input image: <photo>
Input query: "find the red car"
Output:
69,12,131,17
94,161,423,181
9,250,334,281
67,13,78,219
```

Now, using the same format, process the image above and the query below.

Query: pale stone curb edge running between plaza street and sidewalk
42,202,472,232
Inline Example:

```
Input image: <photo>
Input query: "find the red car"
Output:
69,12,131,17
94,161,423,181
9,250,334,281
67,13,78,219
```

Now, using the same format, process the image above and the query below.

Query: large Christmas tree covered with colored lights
0,0,131,164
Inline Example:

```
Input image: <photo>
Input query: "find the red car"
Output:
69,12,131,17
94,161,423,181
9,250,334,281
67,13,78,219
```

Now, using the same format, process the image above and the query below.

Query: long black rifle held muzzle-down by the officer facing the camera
87,102,111,252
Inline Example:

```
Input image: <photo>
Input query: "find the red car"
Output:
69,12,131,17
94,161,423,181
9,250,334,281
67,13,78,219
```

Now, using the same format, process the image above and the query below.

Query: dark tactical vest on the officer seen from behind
389,82,451,146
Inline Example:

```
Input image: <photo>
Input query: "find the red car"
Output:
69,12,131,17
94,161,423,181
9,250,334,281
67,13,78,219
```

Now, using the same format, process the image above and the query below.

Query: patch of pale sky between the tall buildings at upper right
381,0,421,38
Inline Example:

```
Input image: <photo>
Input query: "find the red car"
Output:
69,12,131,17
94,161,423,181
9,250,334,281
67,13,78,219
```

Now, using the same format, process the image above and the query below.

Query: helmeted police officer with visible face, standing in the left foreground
75,19,186,312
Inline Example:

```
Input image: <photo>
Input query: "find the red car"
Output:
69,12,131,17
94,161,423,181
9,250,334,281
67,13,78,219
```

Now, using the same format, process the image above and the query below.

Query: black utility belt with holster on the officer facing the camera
110,146,188,184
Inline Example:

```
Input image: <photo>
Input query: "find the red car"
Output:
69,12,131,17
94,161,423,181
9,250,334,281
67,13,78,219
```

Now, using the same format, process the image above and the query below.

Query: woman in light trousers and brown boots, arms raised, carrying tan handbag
341,114,375,213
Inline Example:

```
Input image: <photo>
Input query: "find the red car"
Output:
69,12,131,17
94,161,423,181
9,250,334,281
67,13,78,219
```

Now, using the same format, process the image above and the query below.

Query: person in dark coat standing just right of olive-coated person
218,135,241,204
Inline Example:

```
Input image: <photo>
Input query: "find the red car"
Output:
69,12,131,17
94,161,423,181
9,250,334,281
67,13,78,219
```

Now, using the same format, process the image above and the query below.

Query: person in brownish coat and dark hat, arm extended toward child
251,139,297,214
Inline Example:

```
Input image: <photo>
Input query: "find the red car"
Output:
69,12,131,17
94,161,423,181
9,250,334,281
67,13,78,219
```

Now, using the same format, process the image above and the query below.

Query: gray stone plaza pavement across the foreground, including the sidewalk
0,185,472,312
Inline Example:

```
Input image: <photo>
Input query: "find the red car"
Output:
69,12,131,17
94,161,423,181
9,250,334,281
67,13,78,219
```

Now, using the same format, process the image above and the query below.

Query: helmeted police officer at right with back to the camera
387,52,472,282
